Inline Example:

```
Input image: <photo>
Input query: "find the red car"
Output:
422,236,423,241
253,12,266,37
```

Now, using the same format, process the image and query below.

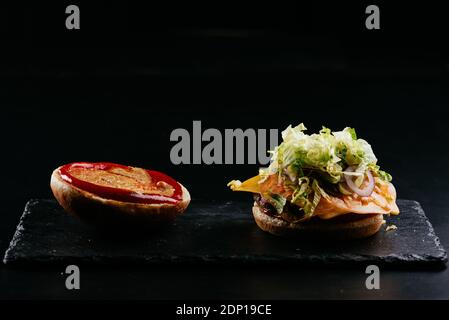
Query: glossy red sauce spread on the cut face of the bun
59,162,182,204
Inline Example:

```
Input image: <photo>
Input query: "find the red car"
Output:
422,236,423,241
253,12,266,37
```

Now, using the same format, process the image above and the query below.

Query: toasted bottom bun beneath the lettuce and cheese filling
253,203,384,239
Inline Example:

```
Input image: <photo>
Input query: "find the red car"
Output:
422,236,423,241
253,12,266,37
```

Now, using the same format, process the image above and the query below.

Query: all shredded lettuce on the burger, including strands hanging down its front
259,123,391,217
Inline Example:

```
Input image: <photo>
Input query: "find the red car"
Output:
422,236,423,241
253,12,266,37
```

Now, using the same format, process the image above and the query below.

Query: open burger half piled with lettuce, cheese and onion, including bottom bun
228,124,399,239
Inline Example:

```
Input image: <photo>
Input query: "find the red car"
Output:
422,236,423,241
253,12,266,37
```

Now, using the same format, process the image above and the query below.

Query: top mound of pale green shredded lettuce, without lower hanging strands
262,123,389,183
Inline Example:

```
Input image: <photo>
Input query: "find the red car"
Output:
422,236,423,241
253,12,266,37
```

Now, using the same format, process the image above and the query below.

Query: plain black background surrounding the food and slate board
0,2,449,299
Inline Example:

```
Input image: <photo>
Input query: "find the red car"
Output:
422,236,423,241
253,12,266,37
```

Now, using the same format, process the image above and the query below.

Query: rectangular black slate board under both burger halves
4,200,447,266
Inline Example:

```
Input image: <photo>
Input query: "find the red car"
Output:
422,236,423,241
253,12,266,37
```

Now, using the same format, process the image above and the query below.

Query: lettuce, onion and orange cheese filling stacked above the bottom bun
229,124,399,222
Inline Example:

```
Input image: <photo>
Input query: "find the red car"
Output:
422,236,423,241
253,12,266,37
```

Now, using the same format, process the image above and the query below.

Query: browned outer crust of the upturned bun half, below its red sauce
50,168,190,228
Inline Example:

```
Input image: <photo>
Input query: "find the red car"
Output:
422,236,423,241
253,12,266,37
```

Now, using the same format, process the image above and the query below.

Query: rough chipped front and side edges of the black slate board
3,199,448,267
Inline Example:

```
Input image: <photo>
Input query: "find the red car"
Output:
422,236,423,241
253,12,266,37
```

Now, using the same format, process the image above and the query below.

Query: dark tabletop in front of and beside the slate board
0,189,449,300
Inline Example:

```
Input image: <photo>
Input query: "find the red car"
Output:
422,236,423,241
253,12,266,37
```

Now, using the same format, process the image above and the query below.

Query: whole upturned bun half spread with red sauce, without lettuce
50,162,190,228
